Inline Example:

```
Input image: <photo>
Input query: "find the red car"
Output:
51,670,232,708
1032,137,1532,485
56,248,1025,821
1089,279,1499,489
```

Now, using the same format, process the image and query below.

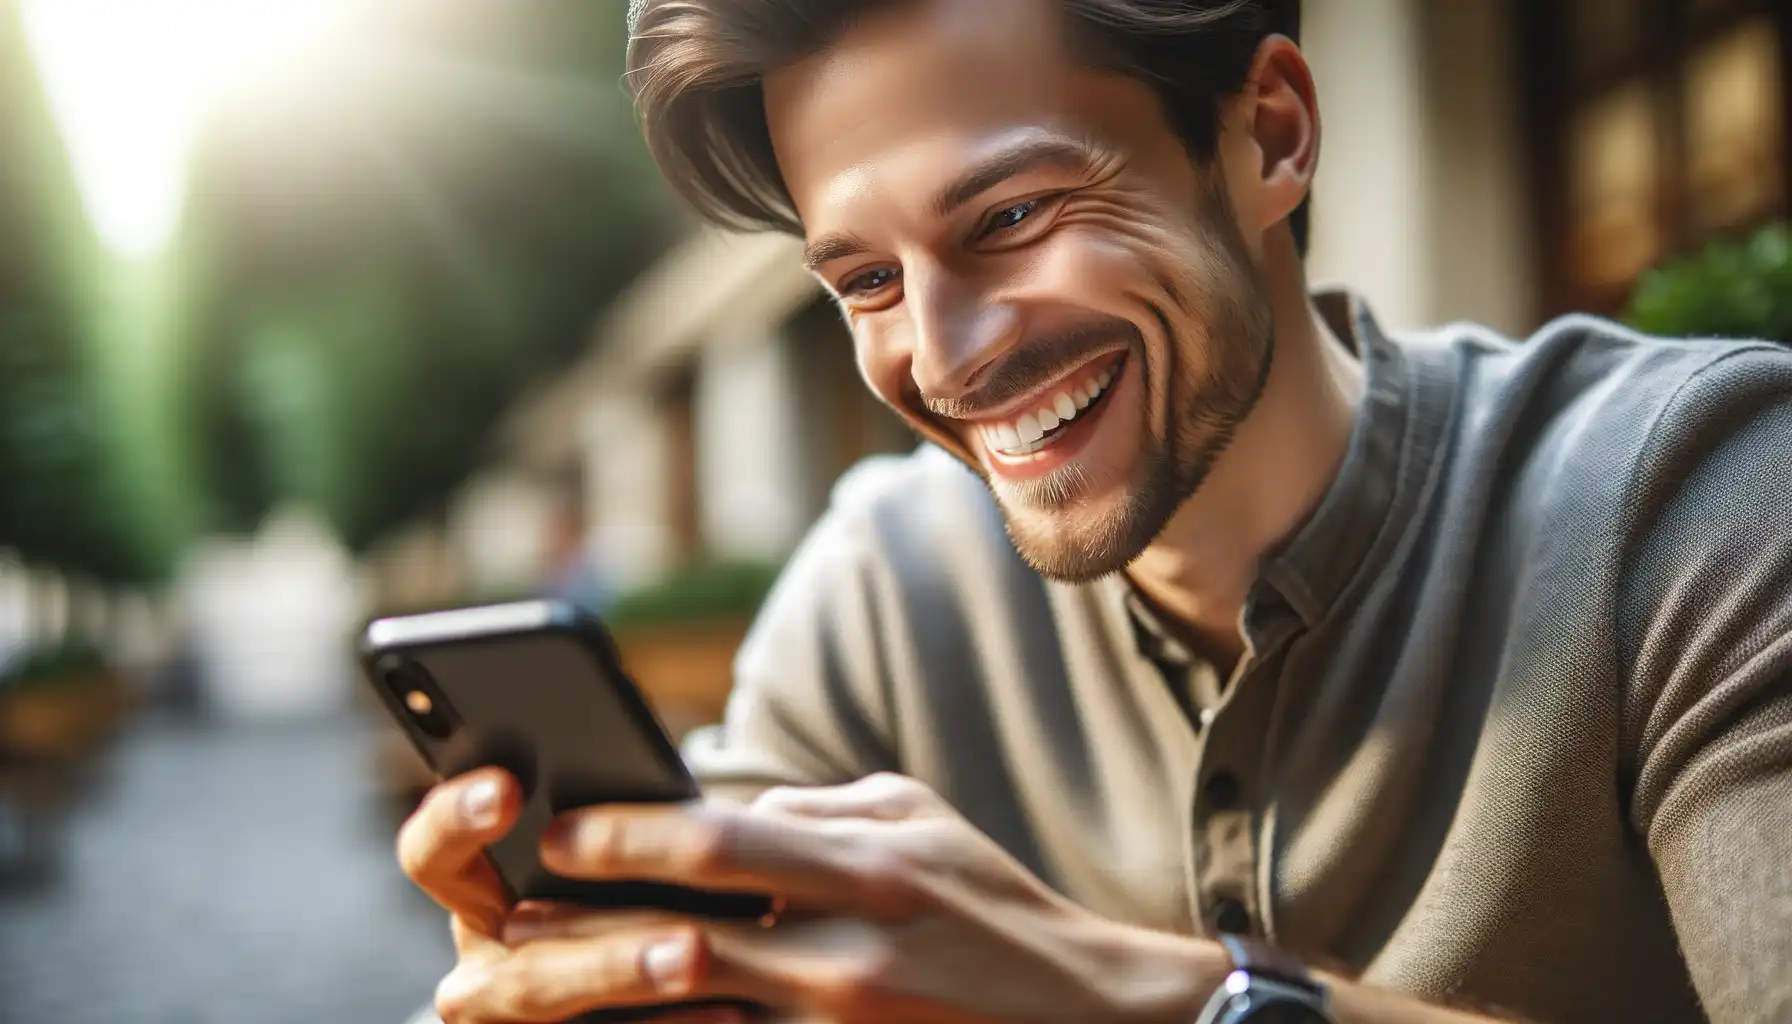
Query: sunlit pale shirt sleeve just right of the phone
685,457,900,800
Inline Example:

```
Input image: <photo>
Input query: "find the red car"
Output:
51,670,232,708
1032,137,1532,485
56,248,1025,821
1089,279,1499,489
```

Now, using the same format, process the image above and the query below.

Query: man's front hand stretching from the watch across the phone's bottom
439,775,1228,1024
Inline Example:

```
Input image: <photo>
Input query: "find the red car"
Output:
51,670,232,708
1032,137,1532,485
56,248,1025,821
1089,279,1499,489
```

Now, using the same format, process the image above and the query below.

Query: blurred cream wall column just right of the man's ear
1301,0,1534,332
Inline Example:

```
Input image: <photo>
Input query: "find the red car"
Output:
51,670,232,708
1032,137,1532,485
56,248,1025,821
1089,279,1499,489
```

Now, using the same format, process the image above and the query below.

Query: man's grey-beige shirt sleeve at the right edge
1620,348,1792,1022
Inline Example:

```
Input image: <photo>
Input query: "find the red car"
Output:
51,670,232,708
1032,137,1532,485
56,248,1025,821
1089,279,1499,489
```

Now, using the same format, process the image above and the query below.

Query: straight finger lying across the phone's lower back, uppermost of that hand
541,803,910,916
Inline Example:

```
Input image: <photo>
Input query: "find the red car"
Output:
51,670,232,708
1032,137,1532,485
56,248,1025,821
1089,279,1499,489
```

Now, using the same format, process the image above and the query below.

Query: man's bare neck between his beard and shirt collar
1127,233,1364,665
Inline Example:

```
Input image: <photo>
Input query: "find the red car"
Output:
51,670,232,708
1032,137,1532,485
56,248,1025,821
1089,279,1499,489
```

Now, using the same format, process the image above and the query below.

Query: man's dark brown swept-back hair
629,0,1306,255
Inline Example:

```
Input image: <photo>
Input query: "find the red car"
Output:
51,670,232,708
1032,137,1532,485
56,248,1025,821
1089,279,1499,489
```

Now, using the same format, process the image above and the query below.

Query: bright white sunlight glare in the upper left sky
22,0,353,258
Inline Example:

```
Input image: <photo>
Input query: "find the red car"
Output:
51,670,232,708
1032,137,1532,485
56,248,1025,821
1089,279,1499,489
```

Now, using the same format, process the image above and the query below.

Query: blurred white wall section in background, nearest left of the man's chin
697,335,806,558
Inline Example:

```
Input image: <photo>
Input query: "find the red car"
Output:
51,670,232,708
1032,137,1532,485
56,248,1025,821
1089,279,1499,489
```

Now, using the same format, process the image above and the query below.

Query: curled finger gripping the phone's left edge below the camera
398,768,520,934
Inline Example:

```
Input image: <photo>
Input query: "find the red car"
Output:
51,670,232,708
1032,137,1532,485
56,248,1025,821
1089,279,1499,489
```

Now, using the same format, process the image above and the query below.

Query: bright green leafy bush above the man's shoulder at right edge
1625,224,1792,344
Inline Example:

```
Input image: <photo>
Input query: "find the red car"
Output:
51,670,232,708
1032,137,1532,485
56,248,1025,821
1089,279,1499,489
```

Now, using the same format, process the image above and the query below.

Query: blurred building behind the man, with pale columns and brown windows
418,0,1792,606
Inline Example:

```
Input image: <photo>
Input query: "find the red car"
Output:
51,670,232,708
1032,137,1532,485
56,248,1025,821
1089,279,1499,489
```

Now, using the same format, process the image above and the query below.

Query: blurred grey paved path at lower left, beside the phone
0,721,452,1024
